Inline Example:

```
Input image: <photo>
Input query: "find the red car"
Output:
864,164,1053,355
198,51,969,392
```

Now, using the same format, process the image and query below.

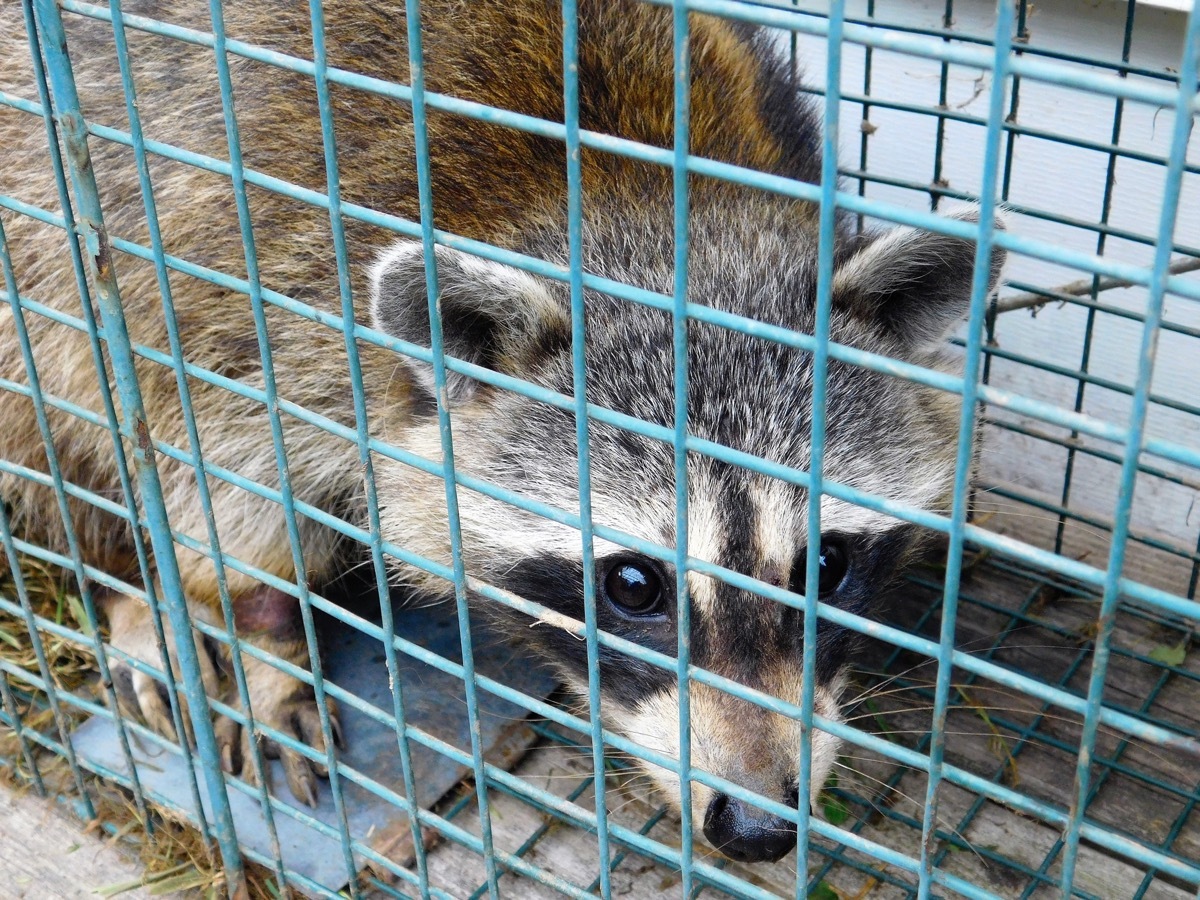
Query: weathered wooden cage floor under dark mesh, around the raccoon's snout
350,563,1200,898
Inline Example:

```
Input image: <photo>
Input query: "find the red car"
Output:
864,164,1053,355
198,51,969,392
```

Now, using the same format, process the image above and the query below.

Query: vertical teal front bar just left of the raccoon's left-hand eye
563,0,612,900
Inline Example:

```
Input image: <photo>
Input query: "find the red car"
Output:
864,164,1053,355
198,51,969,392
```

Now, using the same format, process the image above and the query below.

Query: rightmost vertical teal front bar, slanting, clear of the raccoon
1062,7,1200,899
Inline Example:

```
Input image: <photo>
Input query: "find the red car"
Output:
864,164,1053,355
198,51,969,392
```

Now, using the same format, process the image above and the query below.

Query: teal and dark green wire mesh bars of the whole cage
0,0,1200,900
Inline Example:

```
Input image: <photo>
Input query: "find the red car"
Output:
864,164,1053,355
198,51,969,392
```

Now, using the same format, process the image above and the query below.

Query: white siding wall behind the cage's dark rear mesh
782,0,1200,563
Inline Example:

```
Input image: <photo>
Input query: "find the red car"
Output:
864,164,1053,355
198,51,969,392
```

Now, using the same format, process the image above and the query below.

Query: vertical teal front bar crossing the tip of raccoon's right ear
917,0,1015,900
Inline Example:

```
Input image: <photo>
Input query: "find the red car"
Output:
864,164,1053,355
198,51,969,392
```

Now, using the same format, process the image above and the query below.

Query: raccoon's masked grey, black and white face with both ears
373,200,1001,860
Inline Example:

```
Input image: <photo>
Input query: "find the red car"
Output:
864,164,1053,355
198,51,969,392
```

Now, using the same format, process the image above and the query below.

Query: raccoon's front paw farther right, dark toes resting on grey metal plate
241,642,344,806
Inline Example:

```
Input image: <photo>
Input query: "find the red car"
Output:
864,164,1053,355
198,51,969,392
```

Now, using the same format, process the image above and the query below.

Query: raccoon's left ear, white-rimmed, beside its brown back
371,241,570,403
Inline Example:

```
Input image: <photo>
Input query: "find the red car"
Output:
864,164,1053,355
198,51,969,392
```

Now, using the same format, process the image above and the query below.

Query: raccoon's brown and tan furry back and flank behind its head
0,0,820,578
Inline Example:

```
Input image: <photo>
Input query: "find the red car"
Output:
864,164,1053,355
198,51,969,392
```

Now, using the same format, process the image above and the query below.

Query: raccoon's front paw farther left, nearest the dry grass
101,593,224,744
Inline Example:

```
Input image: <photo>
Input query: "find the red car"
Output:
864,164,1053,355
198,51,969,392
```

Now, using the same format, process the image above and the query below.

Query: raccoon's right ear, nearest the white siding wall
833,208,1004,353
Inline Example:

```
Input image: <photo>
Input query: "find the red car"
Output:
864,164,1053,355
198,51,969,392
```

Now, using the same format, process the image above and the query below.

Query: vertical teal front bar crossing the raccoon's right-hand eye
796,0,846,900
